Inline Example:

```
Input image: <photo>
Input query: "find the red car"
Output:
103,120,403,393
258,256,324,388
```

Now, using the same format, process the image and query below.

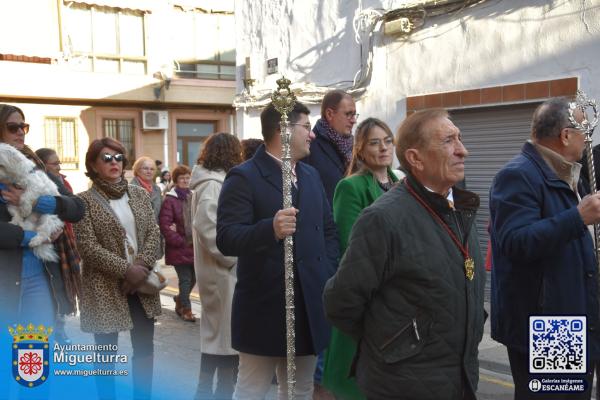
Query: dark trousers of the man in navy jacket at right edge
507,348,594,400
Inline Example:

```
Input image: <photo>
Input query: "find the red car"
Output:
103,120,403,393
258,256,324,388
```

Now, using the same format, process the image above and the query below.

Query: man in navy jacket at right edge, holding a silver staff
490,98,600,399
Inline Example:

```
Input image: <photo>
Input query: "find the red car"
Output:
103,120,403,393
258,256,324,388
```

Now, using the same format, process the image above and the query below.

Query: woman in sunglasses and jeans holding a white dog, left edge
0,104,84,332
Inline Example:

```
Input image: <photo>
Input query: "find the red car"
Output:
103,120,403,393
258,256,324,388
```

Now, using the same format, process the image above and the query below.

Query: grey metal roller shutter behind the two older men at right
450,103,539,257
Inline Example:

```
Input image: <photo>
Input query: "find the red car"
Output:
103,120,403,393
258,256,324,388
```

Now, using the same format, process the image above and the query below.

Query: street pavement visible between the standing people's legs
57,267,524,400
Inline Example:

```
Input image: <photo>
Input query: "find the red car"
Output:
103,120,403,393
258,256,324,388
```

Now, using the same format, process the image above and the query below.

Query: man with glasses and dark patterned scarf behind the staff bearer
303,90,358,204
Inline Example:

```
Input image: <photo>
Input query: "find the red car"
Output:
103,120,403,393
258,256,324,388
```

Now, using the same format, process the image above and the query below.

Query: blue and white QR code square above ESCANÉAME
529,316,586,374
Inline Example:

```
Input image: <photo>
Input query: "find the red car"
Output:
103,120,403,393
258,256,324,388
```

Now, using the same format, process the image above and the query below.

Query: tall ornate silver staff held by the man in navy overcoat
271,76,296,400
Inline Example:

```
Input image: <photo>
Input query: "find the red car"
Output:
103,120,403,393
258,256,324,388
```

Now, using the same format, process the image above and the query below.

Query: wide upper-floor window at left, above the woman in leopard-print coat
63,4,147,75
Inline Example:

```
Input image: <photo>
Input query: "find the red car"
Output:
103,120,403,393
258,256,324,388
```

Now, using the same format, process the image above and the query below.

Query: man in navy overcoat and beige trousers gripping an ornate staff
217,103,339,400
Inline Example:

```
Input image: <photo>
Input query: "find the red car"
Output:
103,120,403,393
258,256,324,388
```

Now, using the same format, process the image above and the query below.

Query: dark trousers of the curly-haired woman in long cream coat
195,353,239,400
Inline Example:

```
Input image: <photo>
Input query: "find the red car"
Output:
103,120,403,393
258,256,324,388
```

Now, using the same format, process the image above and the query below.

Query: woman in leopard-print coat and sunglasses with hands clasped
74,137,161,399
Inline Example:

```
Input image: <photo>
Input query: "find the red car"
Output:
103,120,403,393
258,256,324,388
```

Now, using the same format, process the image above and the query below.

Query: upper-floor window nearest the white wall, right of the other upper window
173,9,235,80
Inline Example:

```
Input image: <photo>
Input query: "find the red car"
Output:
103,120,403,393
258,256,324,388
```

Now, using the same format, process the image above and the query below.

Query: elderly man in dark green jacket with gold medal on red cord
324,109,485,400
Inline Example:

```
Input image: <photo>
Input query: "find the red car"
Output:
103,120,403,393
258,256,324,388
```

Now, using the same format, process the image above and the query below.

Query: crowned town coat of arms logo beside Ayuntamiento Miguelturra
8,323,52,387
